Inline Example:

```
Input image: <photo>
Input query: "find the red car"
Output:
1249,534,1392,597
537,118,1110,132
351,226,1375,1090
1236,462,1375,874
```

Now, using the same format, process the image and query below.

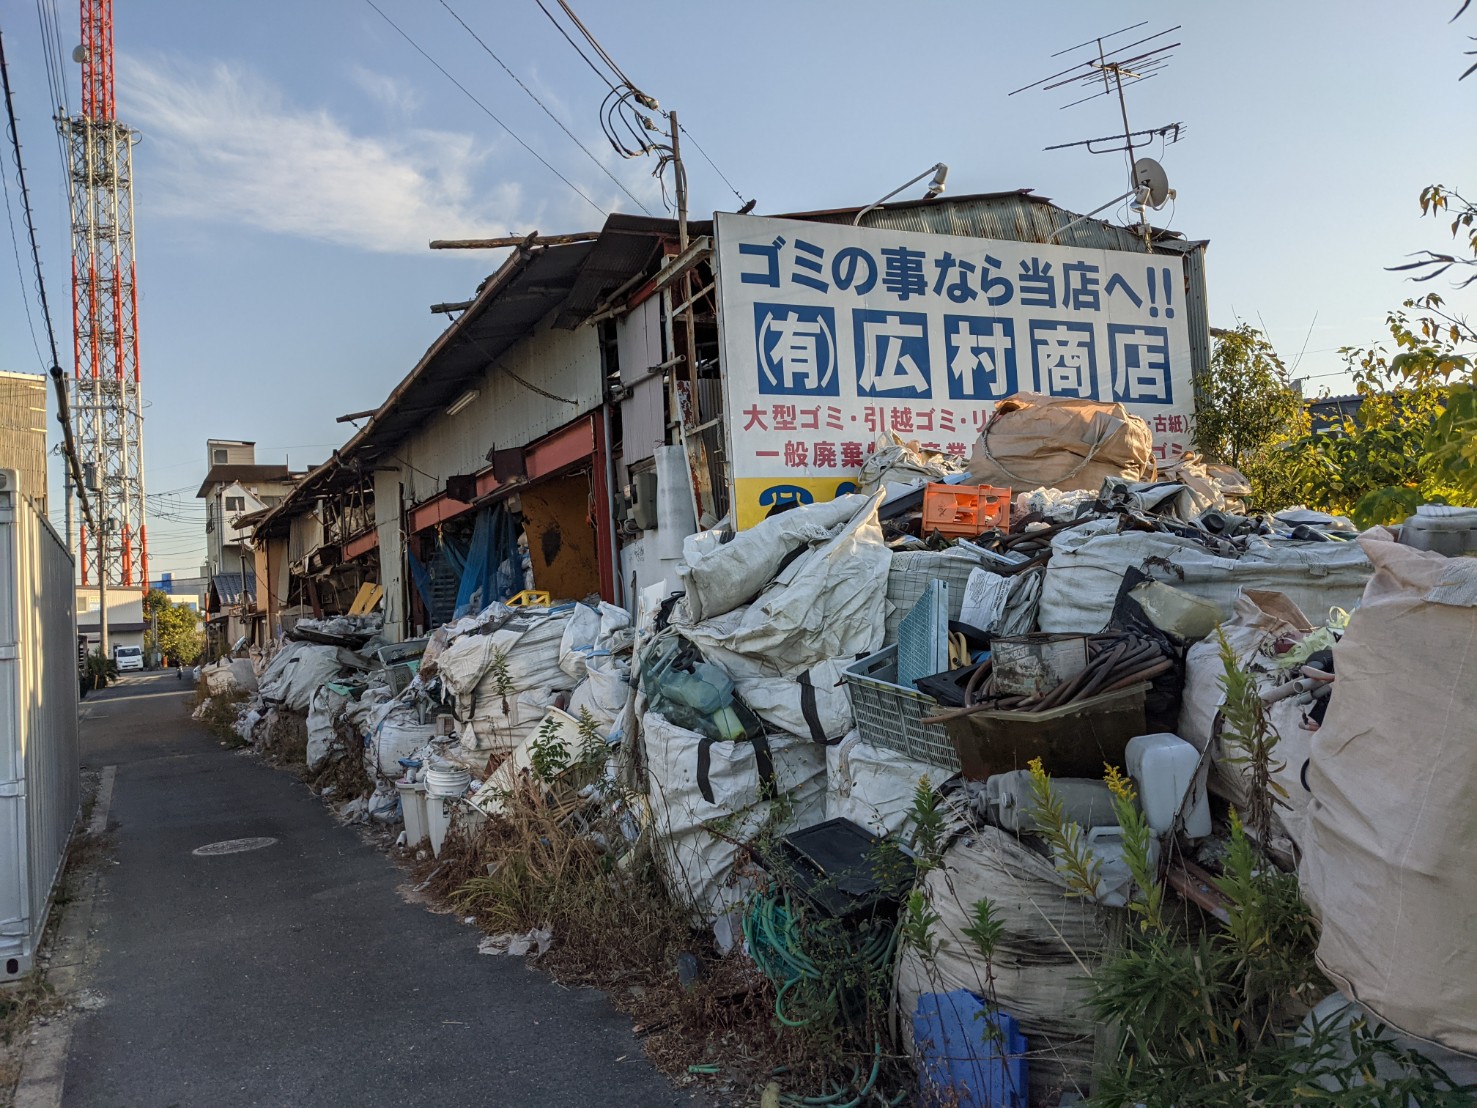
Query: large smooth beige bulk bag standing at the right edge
1298,527,1477,1055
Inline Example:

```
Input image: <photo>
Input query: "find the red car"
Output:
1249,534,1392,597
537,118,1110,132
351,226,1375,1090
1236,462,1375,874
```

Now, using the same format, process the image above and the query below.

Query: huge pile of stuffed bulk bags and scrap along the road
205,396,1477,1105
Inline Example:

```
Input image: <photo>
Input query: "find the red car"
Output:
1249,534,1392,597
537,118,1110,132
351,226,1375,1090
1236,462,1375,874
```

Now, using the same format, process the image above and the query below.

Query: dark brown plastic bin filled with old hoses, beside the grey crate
945,683,1149,782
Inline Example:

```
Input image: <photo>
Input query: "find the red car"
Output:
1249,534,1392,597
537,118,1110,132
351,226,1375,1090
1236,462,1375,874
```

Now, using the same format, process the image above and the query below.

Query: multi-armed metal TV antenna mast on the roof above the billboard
1010,21,1185,242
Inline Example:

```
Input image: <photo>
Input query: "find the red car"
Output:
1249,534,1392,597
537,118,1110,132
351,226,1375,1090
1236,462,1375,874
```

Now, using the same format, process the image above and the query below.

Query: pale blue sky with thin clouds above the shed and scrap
0,0,1477,572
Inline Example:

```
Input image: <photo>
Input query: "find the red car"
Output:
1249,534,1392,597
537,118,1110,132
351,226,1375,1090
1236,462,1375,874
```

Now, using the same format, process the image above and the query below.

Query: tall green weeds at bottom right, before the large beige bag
1081,650,1473,1108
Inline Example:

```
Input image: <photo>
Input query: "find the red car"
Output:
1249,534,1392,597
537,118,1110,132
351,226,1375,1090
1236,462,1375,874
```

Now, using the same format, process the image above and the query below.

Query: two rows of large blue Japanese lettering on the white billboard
744,234,1176,405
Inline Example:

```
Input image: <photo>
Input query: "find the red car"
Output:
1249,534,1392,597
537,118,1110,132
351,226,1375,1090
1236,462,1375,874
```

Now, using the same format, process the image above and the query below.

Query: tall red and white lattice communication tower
59,0,149,589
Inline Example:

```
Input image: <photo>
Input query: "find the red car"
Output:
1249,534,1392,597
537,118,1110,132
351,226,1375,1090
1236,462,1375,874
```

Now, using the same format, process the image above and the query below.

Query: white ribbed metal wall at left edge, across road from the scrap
0,470,81,981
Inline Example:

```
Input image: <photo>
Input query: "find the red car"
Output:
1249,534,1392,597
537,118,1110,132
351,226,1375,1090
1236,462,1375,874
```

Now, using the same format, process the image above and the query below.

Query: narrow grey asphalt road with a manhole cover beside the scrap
62,674,691,1108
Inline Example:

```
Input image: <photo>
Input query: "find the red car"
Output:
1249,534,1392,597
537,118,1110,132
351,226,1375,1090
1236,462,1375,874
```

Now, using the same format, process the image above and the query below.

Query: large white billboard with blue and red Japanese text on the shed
715,213,1193,527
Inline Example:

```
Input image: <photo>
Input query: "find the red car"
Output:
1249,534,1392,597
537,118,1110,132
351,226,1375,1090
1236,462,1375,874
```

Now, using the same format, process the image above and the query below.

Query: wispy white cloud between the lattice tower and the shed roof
120,56,573,254
